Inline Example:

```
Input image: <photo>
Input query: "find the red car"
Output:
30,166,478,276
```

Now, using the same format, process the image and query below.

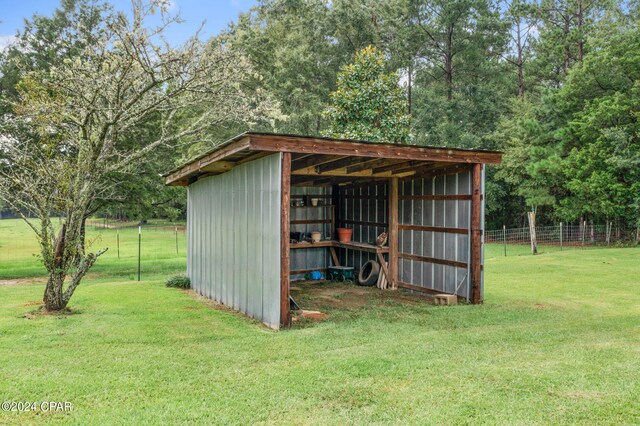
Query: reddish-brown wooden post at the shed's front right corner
471,164,482,304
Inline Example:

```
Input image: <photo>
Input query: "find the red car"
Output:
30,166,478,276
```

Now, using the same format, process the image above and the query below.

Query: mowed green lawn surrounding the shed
0,221,640,425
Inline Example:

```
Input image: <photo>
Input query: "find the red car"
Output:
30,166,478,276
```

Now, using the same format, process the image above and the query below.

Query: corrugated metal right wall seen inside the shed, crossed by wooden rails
398,172,484,299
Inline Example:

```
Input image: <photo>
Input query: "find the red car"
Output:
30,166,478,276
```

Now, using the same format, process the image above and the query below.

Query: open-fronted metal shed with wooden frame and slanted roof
164,133,501,328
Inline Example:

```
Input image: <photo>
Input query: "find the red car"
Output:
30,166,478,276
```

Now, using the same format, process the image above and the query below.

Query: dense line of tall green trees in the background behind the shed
0,0,640,233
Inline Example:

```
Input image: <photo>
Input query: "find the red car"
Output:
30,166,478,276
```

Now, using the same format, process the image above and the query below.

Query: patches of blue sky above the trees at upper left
0,0,256,50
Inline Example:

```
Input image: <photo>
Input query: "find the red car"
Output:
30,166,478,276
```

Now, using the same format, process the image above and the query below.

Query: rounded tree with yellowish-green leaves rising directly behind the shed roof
325,46,411,143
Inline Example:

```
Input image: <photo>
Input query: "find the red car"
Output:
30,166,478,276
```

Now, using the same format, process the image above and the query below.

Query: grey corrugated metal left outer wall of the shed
187,154,281,328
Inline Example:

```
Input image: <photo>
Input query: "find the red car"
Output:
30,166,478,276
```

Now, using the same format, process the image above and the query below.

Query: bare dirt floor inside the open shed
291,281,433,322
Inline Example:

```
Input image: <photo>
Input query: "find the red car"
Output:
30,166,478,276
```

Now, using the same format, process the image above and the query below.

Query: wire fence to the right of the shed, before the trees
484,222,640,256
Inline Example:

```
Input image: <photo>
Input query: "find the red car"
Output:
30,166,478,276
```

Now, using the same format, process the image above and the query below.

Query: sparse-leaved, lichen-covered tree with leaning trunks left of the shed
0,0,278,311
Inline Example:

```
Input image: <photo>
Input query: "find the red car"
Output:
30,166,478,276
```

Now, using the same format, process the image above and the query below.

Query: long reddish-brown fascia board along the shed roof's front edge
247,133,502,164
